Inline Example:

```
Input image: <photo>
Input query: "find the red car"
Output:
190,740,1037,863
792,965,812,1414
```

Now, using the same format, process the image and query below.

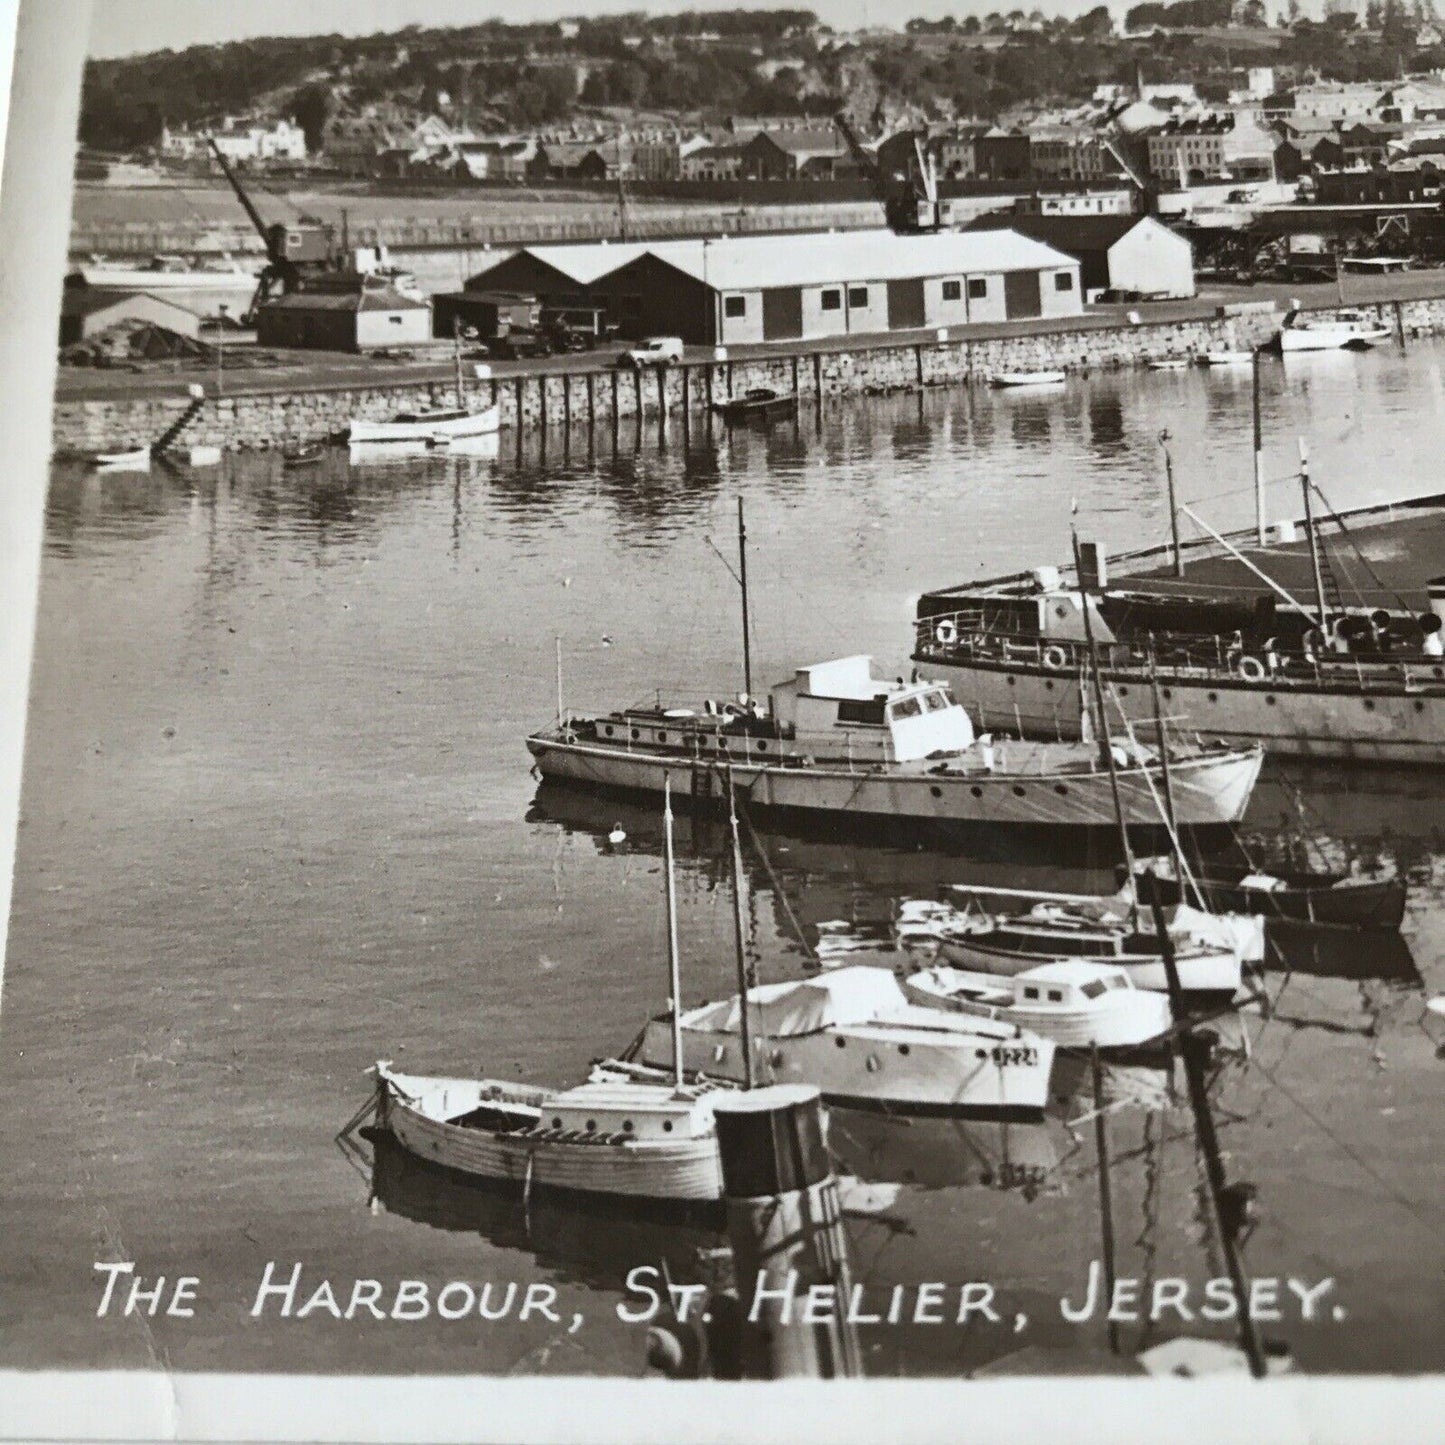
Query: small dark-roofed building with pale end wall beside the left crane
256,276,432,351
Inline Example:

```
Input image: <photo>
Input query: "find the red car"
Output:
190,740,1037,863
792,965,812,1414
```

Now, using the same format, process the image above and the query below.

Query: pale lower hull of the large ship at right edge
916,657,1445,767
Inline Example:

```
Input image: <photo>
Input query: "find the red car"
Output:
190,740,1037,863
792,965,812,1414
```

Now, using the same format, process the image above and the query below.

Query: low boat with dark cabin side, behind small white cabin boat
899,903,1243,996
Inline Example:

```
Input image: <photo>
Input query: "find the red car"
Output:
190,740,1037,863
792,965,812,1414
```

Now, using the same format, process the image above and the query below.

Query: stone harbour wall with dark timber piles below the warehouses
55,299,1445,457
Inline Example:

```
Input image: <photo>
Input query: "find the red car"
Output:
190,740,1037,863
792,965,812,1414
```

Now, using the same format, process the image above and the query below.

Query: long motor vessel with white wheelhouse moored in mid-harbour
526,656,1263,834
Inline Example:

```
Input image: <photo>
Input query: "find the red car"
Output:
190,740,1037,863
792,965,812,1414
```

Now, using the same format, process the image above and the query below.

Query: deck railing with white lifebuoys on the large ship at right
913,608,1445,695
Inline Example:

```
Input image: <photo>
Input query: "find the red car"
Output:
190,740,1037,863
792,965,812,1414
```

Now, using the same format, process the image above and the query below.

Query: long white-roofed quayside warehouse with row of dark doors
537,231,1082,345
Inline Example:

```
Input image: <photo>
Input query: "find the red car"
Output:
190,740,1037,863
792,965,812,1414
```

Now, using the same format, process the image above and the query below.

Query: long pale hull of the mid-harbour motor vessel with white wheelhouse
527,731,1261,831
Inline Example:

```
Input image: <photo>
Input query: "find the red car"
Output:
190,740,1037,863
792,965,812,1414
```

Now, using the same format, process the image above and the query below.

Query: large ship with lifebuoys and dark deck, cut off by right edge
913,497,1445,766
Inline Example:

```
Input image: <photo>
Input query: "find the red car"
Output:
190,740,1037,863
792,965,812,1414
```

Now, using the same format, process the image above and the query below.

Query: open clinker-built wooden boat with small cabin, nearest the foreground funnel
373,1061,723,1201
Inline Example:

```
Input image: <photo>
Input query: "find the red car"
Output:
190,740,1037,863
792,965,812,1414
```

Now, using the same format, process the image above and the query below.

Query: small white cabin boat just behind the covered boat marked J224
903,958,1170,1049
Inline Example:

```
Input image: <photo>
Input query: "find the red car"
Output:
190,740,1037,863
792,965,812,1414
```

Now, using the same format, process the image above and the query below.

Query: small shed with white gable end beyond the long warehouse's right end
971,214,1195,298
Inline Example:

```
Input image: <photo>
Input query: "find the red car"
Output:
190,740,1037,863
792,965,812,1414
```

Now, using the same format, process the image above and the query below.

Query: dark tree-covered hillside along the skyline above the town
81,0,1445,152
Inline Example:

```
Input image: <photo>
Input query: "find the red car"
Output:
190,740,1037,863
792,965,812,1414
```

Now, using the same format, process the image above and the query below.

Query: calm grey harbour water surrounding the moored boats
0,345,1445,1376
